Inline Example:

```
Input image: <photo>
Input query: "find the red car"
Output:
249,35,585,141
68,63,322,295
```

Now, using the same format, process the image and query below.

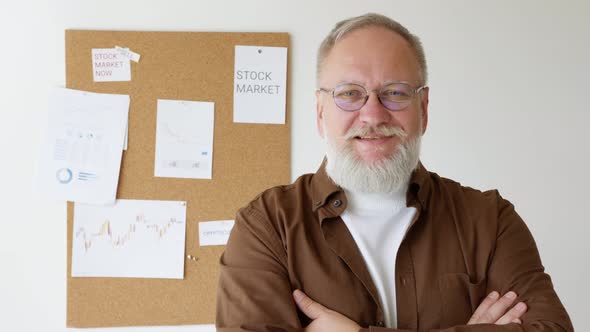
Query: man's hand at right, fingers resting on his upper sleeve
467,291,527,325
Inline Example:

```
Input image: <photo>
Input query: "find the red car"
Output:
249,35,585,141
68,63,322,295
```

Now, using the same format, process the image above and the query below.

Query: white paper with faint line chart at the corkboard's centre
154,99,214,179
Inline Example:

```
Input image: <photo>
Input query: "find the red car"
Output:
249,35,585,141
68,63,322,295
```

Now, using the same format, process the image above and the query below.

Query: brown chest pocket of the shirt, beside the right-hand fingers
438,273,487,328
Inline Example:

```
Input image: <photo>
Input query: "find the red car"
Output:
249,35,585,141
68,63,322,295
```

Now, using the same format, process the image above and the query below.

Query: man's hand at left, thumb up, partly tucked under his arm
293,289,361,332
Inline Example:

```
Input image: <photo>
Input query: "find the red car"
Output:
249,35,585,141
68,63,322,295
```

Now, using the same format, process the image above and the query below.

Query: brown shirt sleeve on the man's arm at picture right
360,191,574,332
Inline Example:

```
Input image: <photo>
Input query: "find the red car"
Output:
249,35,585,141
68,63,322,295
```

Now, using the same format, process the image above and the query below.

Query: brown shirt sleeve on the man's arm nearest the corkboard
215,206,302,332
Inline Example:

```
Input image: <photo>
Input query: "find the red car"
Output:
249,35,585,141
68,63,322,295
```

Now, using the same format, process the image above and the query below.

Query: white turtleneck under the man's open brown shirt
340,187,416,328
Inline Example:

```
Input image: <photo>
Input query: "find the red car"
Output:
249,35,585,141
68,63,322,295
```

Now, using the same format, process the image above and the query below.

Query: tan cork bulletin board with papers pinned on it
66,30,290,327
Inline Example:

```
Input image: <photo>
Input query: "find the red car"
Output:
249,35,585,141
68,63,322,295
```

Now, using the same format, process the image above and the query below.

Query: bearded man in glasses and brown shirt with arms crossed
217,14,573,332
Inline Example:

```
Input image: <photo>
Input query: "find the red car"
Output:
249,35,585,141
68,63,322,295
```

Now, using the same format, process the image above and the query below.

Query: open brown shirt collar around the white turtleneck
311,158,430,211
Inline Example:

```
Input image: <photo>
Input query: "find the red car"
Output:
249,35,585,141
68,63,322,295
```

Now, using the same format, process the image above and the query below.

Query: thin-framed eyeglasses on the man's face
318,82,426,112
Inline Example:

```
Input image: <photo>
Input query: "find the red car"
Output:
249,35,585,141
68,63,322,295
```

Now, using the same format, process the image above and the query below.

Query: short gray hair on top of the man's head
316,13,428,85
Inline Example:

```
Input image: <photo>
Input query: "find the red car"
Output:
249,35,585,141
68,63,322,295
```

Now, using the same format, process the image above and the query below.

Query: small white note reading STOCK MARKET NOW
92,48,131,82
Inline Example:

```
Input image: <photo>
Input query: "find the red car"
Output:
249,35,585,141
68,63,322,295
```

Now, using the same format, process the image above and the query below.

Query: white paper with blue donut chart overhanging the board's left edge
35,88,129,204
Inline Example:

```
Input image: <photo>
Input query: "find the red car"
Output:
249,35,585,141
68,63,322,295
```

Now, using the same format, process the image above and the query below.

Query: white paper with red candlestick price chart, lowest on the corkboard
72,200,186,279
